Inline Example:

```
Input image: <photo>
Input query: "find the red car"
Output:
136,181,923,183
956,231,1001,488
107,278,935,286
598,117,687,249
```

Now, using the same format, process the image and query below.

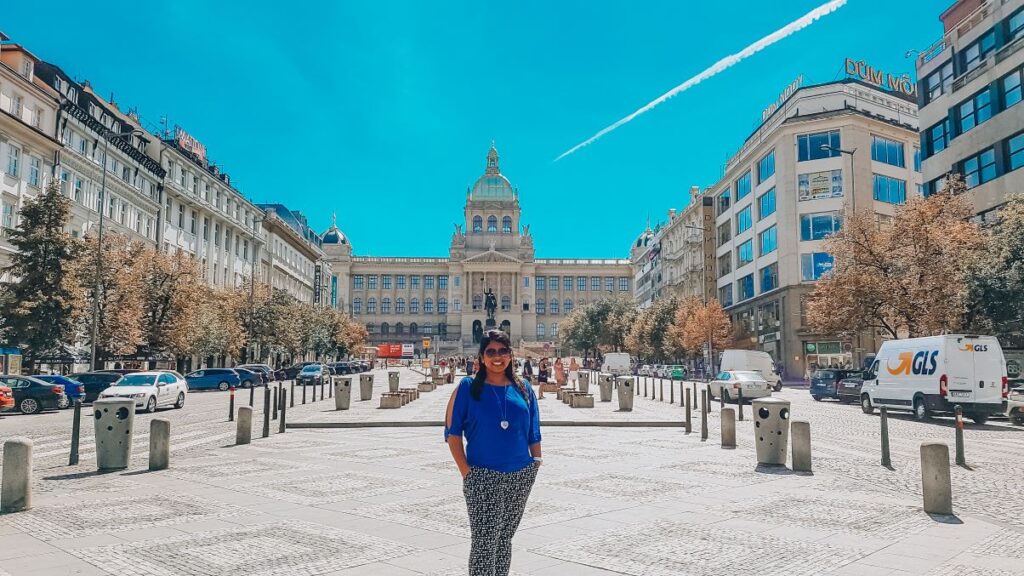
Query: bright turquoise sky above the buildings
8,0,952,257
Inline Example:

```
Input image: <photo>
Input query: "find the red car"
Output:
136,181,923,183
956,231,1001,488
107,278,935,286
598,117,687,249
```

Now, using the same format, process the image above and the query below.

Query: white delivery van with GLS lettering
860,334,1008,424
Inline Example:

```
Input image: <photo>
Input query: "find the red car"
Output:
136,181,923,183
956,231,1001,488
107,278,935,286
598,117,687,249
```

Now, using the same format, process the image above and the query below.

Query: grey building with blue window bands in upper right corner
918,0,1024,219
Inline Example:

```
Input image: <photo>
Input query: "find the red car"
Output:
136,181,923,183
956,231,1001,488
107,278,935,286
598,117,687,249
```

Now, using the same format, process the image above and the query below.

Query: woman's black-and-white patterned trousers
462,463,538,576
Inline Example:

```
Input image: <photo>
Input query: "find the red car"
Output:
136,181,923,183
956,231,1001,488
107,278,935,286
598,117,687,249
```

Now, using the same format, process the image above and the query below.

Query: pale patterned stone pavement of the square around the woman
0,370,1024,576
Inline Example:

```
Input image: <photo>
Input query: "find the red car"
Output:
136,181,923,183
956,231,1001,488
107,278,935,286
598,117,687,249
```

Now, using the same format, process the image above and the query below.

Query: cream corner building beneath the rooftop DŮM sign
710,79,921,377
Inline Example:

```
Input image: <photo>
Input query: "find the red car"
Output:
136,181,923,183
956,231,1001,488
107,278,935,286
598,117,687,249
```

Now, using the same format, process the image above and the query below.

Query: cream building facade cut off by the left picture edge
0,39,60,282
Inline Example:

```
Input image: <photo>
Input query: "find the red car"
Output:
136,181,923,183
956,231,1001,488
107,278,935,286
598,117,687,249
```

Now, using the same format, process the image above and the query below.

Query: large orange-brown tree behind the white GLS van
807,174,984,337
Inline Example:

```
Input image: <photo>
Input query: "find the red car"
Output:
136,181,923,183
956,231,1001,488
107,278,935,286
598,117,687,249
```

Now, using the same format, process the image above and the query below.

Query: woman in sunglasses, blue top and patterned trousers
444,330,543,576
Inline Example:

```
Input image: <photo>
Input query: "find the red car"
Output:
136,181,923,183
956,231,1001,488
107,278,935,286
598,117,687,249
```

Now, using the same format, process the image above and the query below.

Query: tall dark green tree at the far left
0,179,83,365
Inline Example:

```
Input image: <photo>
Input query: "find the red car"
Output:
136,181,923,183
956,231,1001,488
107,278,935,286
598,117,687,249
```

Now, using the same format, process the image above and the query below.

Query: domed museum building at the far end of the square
323,147,633,355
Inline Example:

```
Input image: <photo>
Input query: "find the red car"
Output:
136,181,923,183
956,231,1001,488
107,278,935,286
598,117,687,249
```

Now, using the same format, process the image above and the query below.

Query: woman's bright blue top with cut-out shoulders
444,377,541,472
